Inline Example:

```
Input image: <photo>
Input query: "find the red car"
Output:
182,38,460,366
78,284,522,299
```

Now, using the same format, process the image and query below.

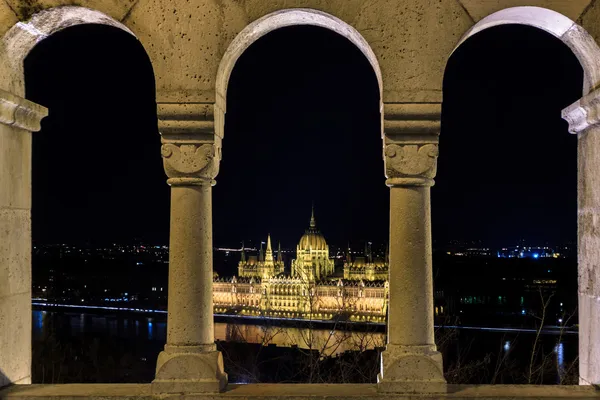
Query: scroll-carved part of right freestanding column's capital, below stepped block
385,144,438,186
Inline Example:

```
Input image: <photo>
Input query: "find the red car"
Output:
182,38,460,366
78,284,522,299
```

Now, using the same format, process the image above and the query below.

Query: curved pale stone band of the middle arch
215,8,383,137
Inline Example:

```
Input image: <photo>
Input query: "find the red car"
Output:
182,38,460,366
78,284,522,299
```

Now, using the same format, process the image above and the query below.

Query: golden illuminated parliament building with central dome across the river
213,210,388,322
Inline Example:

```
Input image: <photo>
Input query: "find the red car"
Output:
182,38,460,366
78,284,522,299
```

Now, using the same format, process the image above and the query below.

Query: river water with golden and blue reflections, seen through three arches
32,311,577,384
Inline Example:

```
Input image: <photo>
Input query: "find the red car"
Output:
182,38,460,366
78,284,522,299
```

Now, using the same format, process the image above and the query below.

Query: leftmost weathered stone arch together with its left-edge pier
0,6,155,387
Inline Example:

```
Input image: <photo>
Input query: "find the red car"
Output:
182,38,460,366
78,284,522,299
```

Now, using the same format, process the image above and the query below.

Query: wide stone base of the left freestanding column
151,345,227,394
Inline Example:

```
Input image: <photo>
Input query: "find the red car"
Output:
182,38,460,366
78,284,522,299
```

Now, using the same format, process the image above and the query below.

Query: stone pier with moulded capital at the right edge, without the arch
562,90,600,385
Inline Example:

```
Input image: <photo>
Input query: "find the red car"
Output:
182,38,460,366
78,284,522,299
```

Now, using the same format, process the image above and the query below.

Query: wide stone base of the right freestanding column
377,344,446,393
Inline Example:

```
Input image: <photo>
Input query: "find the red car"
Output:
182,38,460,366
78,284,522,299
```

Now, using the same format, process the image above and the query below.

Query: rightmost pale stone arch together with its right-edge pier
446,7,600,385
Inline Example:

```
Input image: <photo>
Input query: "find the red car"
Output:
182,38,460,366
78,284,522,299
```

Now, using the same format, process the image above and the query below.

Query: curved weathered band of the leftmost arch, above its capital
0,6,137,97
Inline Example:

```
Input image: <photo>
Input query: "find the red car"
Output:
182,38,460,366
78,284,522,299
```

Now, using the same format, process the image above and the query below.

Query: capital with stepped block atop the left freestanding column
157,103,222,186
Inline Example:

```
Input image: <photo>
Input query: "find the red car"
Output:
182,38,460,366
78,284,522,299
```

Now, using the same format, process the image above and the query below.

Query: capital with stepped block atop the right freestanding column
383,103,442,186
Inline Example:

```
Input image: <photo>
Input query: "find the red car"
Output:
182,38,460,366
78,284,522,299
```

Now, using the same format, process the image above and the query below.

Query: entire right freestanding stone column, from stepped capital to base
378,104,446,393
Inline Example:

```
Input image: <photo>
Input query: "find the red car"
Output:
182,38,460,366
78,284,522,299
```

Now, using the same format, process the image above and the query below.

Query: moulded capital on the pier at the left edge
0,89,48,132
